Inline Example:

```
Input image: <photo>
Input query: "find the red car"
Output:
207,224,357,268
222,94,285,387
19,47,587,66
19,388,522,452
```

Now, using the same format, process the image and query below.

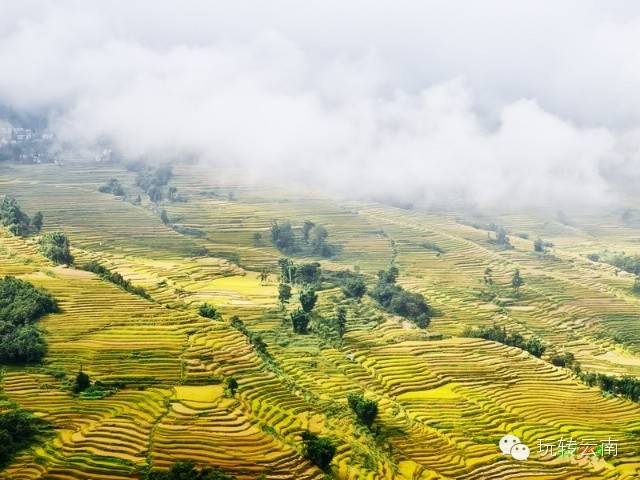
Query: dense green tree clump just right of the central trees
369,267,432,328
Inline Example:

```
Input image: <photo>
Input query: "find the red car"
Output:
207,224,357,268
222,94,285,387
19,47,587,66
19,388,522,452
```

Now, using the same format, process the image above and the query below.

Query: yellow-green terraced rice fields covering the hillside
0,164,640,480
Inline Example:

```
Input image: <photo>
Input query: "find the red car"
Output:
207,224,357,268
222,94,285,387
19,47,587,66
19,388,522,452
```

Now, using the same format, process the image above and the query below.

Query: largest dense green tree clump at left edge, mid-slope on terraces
0,277,58,364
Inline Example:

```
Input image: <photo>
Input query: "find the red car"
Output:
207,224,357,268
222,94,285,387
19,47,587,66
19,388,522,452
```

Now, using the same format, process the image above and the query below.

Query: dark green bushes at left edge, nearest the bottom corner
0,408,49,468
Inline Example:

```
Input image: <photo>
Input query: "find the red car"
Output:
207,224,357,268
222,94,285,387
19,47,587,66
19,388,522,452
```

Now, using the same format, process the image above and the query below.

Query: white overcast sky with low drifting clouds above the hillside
0,0,640,206
